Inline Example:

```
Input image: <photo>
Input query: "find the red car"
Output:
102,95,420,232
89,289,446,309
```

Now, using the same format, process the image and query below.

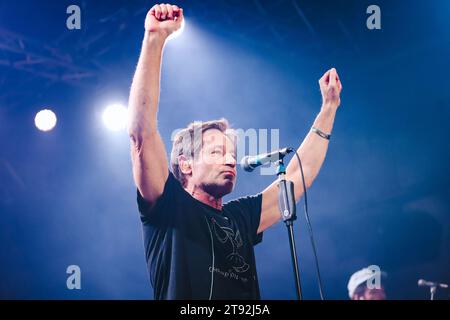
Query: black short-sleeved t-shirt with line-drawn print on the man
137,172,262,299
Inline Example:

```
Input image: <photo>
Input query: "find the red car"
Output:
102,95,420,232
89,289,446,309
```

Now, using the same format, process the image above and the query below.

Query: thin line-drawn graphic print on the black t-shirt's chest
211,218,250,273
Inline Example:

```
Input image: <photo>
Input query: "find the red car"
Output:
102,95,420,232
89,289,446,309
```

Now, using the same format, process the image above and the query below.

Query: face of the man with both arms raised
190,129,236,198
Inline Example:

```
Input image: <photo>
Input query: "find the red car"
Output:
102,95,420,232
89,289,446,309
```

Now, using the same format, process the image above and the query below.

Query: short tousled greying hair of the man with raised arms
170,118,235,187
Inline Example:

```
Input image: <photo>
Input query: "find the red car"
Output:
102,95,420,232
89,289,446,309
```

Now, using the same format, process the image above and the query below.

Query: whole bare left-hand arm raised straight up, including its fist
128,4,183,208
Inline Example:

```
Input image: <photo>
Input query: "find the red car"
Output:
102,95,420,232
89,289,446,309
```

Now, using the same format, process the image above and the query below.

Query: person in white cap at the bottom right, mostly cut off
347,265,387,300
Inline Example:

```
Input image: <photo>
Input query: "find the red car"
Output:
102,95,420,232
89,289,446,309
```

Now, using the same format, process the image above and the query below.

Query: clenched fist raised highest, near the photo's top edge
145,4,183,37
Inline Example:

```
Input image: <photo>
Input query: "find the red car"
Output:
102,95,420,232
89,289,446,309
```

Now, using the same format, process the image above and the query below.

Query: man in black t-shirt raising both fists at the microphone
128,4,342,299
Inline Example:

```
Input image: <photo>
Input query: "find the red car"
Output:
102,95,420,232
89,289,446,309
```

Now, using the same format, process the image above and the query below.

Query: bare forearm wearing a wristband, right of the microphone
286,105,336,201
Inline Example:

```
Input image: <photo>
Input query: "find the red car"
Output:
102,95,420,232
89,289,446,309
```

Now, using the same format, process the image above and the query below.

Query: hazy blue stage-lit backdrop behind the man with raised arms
0,0,450,299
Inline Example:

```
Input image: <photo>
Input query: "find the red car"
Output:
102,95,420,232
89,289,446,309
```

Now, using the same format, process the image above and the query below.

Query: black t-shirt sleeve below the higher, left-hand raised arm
136,171,184,224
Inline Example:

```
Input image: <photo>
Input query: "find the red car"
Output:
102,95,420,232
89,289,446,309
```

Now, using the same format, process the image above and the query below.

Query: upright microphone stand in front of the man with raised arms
277,155,302,300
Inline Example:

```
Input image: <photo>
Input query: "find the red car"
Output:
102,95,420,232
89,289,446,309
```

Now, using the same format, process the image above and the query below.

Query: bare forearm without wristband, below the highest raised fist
128,32,165,135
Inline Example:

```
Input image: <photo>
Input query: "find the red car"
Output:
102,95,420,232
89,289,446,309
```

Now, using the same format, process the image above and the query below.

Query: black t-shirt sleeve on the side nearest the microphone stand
226,193,263,245
